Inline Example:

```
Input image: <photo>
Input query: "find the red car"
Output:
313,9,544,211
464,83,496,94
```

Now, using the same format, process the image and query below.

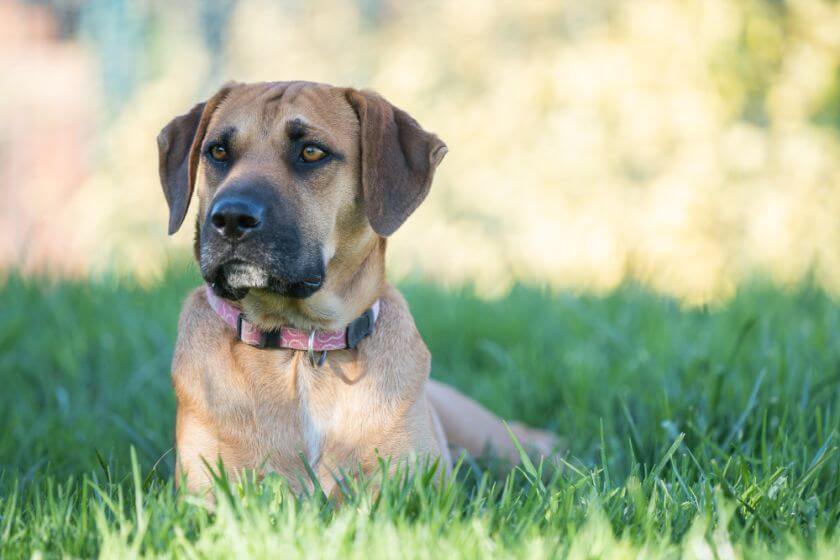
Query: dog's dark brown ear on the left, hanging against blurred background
158,84,233,235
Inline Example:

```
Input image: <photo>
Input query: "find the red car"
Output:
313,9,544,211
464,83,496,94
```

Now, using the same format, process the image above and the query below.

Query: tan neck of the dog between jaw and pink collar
233,236,386,331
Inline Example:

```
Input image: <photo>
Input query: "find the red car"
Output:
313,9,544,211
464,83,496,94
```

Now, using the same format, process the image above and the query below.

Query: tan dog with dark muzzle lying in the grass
158,82,554,492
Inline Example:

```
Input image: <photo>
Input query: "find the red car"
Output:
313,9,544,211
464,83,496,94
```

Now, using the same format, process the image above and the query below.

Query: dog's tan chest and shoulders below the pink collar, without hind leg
173,287,449,488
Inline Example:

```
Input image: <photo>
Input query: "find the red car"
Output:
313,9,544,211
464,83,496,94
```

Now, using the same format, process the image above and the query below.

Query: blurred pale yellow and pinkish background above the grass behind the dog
0,0,840,303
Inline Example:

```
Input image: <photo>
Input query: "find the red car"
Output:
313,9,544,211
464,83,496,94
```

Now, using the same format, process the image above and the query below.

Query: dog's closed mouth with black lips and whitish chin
204,259,323,300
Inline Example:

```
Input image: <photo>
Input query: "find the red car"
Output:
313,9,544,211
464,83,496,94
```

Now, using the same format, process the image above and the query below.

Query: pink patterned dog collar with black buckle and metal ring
206,286,379,365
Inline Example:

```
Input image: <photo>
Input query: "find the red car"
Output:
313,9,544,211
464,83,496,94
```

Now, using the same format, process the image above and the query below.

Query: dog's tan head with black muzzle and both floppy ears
158,82,446,324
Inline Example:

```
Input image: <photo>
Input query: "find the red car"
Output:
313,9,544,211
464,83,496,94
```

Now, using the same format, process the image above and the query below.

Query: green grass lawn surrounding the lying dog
0,267,840,558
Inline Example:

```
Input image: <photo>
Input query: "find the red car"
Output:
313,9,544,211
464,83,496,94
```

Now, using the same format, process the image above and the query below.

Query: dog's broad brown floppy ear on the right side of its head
346,89,447,237
